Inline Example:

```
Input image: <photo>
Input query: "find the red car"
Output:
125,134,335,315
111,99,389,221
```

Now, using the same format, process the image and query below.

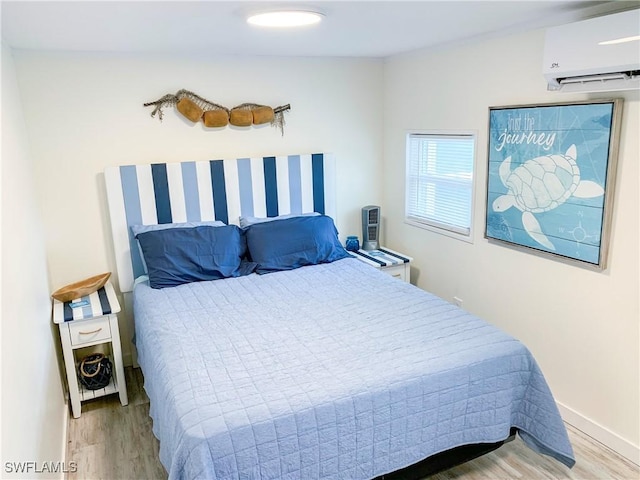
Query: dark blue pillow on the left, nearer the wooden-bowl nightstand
137,225,255,288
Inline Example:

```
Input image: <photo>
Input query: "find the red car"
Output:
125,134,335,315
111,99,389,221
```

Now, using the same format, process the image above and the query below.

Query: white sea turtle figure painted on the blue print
492,145,604,251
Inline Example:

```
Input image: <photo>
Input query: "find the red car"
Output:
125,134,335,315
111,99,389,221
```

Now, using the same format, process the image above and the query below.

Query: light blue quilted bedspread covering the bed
134,259,574,480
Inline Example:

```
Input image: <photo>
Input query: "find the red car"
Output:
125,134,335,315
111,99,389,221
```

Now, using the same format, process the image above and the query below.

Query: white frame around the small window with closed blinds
404,130,478,243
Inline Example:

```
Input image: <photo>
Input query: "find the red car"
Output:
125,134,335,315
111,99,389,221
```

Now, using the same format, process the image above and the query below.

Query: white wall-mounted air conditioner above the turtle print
543,9,640,92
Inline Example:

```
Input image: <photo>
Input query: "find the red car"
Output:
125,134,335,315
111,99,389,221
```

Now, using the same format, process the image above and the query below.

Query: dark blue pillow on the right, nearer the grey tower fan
245,215,350,274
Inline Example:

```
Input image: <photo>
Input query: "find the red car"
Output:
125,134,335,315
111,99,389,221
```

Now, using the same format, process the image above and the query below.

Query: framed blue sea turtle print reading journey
485,99,622,269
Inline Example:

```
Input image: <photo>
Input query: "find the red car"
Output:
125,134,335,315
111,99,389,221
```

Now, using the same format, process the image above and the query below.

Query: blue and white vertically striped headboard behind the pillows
104,153,336,292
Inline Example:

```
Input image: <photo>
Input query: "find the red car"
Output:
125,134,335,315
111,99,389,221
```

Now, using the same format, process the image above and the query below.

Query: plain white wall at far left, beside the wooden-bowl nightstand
0,44,68,478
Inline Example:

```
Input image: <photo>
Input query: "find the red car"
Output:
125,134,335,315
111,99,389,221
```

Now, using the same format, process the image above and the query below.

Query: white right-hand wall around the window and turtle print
383,31,640,463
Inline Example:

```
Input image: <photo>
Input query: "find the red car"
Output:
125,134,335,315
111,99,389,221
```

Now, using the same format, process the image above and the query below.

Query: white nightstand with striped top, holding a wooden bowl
53,283,129,418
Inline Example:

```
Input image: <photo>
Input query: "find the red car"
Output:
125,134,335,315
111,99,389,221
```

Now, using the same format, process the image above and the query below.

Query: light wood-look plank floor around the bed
66,367,640,480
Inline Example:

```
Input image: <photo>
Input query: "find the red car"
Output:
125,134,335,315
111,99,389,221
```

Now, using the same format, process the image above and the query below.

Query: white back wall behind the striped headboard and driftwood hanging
16,51,383,360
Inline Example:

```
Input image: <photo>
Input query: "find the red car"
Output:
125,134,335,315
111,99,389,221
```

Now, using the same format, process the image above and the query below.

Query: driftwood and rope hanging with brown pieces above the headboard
144,90,291,135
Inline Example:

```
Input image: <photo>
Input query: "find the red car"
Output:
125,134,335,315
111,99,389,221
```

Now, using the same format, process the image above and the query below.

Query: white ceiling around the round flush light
2,0,640,58
